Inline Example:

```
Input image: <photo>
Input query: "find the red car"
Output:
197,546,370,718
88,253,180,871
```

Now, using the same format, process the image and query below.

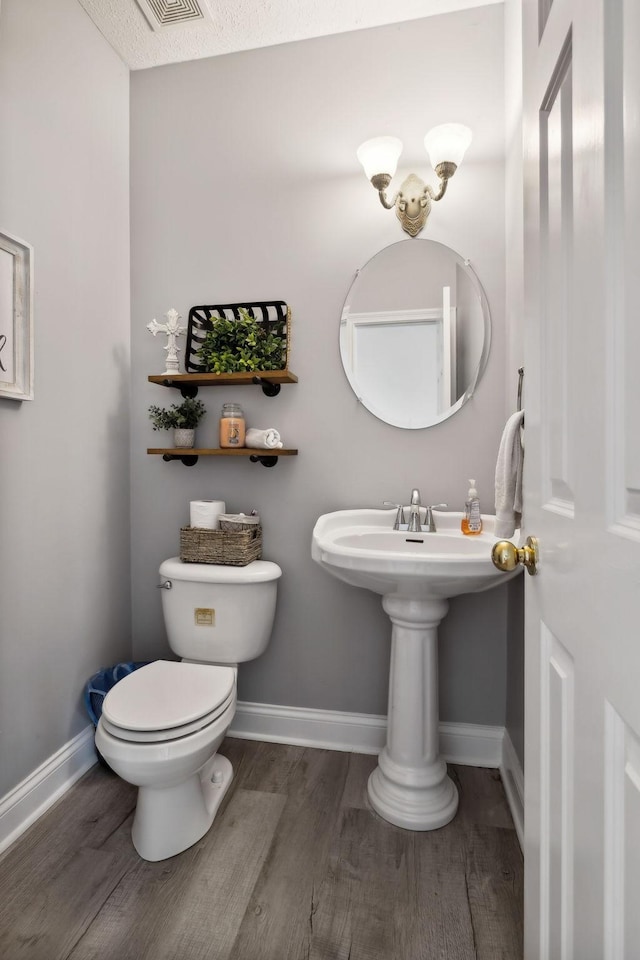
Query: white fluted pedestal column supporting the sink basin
368,593,458,830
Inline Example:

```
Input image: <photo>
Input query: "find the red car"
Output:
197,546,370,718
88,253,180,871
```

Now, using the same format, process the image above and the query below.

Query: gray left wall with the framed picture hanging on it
0,0,130,796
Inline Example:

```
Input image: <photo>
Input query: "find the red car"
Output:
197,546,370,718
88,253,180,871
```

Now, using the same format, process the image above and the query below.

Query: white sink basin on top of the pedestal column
311,510,519,599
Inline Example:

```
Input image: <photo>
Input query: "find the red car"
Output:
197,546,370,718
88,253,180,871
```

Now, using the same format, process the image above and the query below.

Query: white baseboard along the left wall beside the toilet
0,724,97,854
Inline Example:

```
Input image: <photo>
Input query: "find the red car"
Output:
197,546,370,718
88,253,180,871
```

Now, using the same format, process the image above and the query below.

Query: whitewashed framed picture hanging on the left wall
0,232,33,400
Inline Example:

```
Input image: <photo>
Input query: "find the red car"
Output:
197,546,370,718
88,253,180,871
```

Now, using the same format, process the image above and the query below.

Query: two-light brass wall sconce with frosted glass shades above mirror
357,123,472,237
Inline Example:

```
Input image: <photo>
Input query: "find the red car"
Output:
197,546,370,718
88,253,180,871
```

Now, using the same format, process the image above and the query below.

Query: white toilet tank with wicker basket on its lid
159,557,282,663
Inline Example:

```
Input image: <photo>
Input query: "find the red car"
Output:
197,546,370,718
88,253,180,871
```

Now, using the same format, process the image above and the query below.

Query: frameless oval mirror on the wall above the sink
340,239,491,430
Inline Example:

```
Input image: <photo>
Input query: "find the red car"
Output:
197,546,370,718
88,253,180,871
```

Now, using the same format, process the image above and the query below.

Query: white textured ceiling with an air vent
79,0,502,70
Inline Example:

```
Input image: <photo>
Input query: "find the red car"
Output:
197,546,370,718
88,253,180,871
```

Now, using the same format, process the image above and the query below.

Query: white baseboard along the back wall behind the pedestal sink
229,701,504,767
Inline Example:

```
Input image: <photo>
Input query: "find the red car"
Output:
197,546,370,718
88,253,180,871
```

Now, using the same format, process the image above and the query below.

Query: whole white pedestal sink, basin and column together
311,510,521,830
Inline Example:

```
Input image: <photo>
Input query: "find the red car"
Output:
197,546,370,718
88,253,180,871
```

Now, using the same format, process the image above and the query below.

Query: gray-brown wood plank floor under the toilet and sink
0,738,523,960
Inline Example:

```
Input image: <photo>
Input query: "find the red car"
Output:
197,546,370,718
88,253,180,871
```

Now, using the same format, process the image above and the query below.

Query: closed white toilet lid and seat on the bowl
102,660,235,736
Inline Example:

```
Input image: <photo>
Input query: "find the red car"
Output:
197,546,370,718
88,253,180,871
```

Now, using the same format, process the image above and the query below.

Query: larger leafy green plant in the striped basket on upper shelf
197,308,286,373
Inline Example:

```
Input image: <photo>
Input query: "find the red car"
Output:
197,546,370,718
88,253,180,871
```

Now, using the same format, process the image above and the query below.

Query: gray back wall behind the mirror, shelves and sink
131,6,506,724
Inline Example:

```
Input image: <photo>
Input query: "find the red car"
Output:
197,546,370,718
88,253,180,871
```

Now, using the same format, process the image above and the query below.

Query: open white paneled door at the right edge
523,0,640,960
